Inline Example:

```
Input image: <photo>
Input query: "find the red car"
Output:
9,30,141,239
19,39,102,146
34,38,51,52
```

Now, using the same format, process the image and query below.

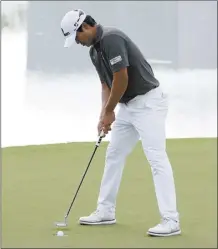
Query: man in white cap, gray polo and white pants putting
61,10,181,236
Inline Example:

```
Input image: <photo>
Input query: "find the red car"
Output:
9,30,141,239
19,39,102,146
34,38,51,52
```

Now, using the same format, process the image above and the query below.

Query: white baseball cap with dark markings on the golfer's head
61,9,86,48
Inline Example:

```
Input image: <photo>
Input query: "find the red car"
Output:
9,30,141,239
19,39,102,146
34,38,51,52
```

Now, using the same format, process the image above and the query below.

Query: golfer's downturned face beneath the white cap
75,24,93,47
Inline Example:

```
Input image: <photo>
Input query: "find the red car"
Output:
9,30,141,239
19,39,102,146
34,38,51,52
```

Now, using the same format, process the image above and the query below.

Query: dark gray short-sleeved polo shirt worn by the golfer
90,25,159,103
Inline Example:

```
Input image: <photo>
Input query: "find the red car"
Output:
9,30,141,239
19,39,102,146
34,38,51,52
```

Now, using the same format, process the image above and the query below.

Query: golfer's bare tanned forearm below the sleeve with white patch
105,79,128,112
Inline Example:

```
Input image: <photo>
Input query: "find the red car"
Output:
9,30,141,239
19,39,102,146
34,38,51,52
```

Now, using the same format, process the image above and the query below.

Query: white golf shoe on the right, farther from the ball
147,219,181,237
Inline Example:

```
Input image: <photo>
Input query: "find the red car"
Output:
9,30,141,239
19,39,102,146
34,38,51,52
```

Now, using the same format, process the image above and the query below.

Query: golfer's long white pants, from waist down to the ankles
98,87,179,220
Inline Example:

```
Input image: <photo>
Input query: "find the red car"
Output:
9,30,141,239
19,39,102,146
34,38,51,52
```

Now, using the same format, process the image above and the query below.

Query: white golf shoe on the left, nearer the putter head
79,210,116,225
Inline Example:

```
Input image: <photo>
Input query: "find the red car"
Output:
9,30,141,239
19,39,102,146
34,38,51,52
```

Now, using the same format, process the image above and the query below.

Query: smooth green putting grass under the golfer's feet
2,139,217,248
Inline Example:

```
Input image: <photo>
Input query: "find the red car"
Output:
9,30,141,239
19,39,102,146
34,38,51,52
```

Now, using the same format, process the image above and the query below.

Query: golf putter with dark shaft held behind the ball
55,131,105,228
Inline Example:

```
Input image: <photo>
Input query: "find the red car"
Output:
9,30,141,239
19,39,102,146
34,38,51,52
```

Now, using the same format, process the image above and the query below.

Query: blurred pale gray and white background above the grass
1,1,217,147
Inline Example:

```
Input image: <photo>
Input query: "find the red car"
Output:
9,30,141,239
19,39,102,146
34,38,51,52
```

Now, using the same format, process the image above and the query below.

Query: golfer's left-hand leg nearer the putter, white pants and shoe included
79,104,139,225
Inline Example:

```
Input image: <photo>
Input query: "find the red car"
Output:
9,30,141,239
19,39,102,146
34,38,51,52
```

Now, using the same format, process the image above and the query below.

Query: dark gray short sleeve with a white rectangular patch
103,34,129,73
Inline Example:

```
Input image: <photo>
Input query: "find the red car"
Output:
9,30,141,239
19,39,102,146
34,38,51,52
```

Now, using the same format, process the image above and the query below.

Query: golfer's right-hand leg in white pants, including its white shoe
129,88,181,236
